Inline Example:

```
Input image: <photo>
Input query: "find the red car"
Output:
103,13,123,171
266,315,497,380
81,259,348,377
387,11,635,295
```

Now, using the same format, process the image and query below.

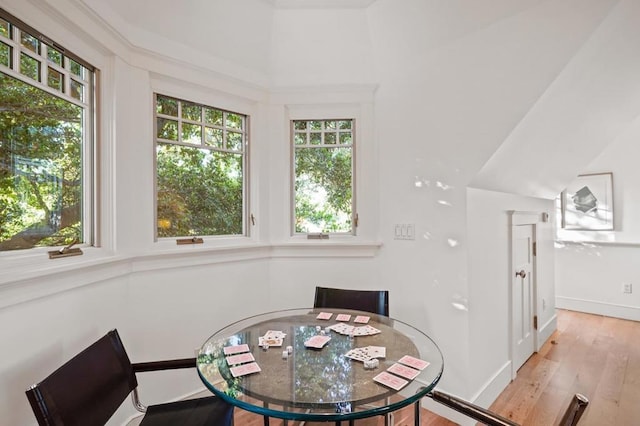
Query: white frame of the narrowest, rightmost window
289,116,358,238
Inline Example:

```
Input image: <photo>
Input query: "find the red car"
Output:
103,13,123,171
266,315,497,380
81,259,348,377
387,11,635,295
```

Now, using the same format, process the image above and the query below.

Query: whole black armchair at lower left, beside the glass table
26,330,233,426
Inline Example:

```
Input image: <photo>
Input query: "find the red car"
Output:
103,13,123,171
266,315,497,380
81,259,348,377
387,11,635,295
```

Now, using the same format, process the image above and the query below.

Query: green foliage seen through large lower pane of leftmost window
0,73,83,251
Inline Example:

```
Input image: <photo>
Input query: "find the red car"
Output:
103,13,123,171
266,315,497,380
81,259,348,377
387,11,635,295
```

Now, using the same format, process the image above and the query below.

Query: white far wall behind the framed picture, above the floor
556,110,640,321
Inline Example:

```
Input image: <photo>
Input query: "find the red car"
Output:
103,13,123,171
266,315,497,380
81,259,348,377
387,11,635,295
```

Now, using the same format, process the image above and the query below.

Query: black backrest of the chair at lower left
26,330,138,426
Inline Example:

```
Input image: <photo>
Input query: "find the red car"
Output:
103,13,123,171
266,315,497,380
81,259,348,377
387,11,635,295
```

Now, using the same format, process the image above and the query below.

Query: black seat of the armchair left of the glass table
140,397,233,426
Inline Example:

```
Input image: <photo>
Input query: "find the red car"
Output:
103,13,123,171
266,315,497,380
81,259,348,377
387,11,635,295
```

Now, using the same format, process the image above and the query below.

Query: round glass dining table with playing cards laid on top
197,308,443,425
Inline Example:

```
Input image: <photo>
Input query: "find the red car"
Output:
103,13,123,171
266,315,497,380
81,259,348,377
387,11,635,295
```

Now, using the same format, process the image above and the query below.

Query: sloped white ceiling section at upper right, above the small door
472,0,640,198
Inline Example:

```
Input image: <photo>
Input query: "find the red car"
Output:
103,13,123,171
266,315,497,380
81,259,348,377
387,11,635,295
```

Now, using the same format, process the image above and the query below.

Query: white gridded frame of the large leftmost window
0,8,96,253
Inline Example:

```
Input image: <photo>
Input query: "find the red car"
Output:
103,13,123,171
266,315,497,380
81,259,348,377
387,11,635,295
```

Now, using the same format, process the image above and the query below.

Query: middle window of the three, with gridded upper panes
155,94,249,237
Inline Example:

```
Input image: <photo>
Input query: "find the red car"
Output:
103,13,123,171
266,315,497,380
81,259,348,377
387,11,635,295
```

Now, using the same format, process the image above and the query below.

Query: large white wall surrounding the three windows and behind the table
0,0,626,425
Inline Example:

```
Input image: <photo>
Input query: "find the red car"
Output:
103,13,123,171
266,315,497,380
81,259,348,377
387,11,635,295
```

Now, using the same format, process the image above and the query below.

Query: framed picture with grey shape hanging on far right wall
561,173,613,231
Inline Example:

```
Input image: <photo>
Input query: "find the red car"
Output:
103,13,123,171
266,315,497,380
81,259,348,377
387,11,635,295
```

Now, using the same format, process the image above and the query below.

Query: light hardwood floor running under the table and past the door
235,310,640,426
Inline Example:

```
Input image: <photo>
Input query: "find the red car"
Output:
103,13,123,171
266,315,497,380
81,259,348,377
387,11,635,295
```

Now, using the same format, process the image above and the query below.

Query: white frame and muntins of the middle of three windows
152,91,255,244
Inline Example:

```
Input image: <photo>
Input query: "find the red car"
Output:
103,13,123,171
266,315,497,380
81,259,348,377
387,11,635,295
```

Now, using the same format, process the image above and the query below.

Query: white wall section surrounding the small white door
467,189,556,403
